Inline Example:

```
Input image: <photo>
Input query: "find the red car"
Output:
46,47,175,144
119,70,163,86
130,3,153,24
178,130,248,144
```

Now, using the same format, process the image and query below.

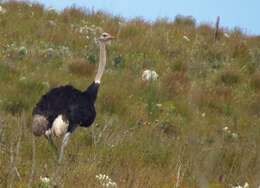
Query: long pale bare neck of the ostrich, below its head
95,42,106,83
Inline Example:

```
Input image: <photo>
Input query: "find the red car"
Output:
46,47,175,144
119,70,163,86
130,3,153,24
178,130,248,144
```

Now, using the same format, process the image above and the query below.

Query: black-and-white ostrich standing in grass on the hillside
32,33,114,163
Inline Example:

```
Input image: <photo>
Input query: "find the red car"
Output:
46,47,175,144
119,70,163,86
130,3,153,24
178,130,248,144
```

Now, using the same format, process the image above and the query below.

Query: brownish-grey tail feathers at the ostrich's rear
32,115,49,136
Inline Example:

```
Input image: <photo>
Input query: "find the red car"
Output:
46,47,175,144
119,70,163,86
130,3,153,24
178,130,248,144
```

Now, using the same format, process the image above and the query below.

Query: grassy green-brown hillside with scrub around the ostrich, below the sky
0,2,260,188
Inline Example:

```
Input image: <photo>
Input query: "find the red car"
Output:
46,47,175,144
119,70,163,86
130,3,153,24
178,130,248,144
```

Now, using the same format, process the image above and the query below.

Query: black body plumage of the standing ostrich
33,82,99,132
